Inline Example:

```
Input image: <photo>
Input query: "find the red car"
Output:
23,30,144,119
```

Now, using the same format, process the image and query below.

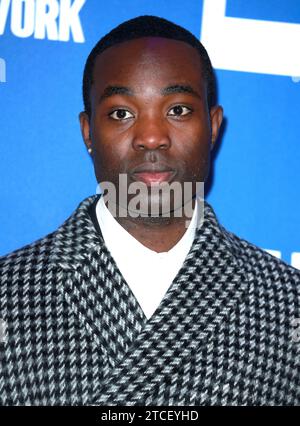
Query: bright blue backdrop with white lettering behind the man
0,0,300,268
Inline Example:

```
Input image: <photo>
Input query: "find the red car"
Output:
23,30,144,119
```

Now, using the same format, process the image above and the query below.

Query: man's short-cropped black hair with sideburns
82,15,216,117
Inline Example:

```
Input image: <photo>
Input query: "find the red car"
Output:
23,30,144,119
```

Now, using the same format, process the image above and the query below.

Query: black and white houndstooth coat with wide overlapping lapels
0,196,300,405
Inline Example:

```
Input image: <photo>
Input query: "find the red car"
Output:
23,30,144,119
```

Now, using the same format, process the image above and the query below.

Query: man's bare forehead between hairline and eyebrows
93,37,203,89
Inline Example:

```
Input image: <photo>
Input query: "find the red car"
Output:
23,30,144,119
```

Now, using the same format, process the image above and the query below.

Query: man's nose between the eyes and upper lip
132,116,171,150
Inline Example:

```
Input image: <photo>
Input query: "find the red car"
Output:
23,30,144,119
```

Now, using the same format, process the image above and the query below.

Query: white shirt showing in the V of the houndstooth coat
96,197,197,319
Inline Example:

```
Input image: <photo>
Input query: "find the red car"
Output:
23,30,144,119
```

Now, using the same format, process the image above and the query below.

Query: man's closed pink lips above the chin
131,163,176,185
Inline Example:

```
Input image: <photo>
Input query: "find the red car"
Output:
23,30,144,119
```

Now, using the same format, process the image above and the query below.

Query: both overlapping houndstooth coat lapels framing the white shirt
51,197,248,405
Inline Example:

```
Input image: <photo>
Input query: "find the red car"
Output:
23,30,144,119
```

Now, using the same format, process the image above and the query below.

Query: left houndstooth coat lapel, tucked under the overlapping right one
51,197,146,367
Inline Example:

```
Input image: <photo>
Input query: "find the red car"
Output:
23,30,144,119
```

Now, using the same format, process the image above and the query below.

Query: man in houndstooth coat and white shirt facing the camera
0,16,300,405
